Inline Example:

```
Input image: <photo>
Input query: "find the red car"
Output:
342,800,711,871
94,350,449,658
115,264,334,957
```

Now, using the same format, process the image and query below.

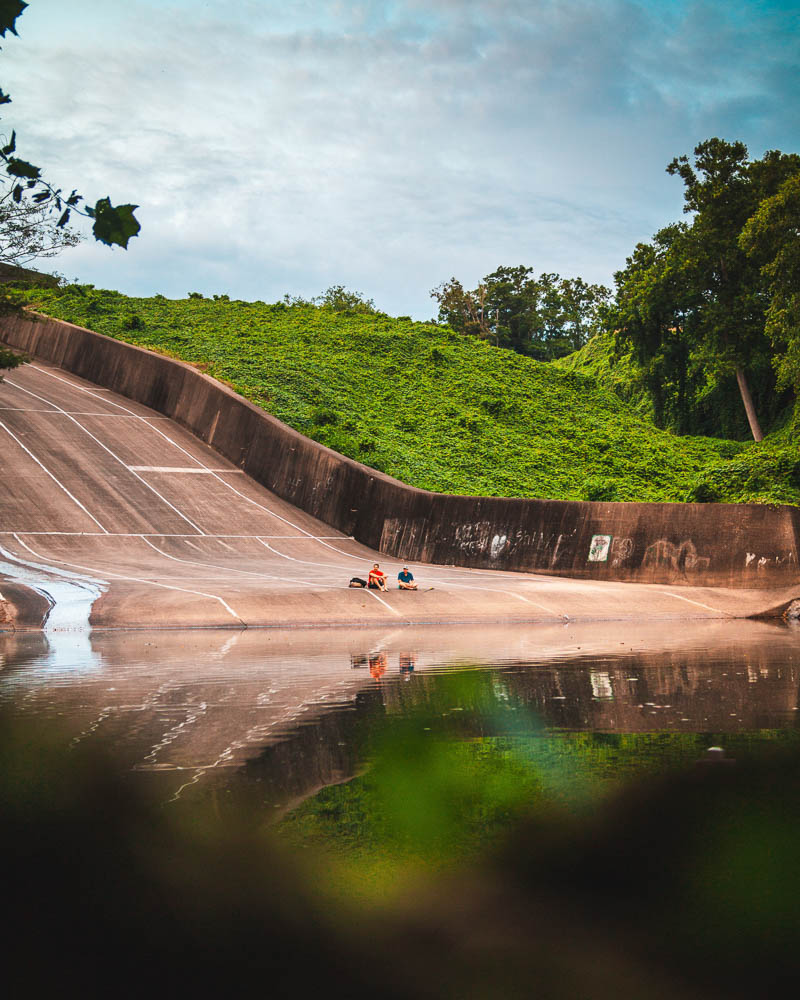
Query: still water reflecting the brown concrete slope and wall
0,621,800,810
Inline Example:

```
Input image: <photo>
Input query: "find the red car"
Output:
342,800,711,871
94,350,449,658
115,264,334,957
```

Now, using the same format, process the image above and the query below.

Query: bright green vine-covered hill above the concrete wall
17,285,800,504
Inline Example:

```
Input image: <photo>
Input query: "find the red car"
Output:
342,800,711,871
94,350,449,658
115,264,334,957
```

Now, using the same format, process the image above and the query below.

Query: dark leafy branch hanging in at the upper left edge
0,0,140,249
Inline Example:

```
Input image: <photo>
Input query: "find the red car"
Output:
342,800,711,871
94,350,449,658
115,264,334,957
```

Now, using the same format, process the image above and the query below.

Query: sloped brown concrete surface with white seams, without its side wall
0,361,798,628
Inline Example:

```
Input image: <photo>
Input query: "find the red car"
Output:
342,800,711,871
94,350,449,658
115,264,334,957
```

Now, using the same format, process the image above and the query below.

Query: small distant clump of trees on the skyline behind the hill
431,264,609,361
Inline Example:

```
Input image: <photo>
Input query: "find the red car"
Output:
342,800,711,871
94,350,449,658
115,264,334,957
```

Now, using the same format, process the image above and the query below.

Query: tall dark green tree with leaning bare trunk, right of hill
609,138,800,441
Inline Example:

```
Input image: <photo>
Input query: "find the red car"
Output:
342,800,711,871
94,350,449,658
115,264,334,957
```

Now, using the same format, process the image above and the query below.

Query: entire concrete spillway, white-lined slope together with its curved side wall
0,318,800,627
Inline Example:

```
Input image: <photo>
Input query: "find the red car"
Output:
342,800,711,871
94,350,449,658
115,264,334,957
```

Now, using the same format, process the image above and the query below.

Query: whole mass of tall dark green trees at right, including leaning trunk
605,138,800,440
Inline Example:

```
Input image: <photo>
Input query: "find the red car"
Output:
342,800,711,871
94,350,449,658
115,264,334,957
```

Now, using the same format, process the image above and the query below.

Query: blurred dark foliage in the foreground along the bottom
0,688,800,1000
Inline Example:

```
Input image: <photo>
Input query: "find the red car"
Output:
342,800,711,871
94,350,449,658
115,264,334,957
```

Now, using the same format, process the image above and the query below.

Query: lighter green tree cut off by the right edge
739,172,800,392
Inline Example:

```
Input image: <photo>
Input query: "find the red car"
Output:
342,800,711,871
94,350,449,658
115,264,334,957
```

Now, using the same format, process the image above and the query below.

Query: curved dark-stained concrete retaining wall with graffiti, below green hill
0,317,800,588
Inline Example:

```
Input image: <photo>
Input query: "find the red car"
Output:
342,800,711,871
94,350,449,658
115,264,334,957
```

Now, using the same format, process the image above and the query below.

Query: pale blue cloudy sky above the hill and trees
0,0,800,320
